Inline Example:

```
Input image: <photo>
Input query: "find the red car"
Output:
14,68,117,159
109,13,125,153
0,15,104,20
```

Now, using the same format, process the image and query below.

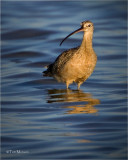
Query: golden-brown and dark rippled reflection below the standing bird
47,89,100,114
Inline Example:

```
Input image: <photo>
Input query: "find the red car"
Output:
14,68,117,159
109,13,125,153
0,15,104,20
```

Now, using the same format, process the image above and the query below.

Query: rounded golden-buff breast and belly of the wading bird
56,53,96,83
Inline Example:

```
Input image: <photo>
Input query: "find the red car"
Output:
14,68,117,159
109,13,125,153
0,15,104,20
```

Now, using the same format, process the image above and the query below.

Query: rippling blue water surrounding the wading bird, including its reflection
1,1,127,160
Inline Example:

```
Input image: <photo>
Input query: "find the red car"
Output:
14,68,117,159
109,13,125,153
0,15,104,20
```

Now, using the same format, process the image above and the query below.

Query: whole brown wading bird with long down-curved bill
43,21,97,89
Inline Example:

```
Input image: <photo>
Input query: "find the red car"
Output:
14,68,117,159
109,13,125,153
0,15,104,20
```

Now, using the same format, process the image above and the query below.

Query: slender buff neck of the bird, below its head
80,32,93,52
